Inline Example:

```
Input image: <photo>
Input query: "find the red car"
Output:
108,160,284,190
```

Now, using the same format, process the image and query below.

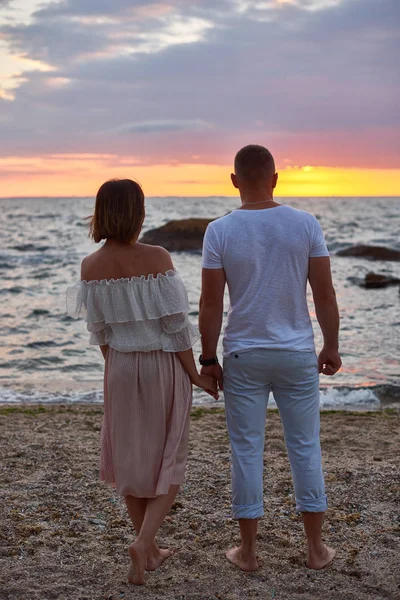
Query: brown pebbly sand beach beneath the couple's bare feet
0,406,400,600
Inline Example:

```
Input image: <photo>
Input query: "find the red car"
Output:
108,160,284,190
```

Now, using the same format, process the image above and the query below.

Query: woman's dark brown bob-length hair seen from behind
89,179,145,244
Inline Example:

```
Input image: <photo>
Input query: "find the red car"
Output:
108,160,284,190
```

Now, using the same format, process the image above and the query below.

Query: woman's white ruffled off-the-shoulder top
67,270,200,352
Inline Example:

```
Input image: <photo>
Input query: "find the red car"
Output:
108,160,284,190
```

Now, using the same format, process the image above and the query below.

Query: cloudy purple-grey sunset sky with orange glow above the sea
0,0,400,197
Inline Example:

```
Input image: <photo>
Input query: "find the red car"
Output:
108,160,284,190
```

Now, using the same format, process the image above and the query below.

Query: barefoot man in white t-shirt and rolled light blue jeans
200,145,341,571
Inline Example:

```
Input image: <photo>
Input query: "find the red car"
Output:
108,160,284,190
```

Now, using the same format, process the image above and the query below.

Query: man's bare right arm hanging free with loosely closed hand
308,256,342,375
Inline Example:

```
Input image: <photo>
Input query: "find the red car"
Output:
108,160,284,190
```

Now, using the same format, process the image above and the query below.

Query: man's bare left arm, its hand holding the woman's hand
199,269,226,389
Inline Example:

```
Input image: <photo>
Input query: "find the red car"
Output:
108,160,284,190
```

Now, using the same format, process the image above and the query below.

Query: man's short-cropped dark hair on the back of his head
235,144,275,182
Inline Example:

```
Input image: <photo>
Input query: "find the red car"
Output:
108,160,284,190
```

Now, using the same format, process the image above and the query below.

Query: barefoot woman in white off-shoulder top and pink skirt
67,179,218,585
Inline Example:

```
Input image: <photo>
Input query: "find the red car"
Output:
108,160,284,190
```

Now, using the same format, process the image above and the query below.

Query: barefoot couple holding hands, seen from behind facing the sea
67,145,341,585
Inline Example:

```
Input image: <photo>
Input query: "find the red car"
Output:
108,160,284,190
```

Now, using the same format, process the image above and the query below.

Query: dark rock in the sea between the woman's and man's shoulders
139,219,214,252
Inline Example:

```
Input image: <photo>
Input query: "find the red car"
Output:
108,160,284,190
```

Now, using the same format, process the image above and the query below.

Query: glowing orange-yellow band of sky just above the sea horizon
0,154,400,197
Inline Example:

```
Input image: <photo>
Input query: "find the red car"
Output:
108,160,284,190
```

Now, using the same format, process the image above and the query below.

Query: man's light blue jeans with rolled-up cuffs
224,349,327,519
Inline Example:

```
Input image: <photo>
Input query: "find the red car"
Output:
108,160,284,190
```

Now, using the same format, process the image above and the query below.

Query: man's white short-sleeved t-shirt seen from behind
202,205,329,356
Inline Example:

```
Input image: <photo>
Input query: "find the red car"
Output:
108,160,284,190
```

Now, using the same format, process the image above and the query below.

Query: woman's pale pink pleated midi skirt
100,348,192,498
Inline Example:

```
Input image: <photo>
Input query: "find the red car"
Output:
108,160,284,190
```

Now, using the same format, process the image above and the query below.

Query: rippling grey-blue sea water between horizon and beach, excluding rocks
0,198,400,408
